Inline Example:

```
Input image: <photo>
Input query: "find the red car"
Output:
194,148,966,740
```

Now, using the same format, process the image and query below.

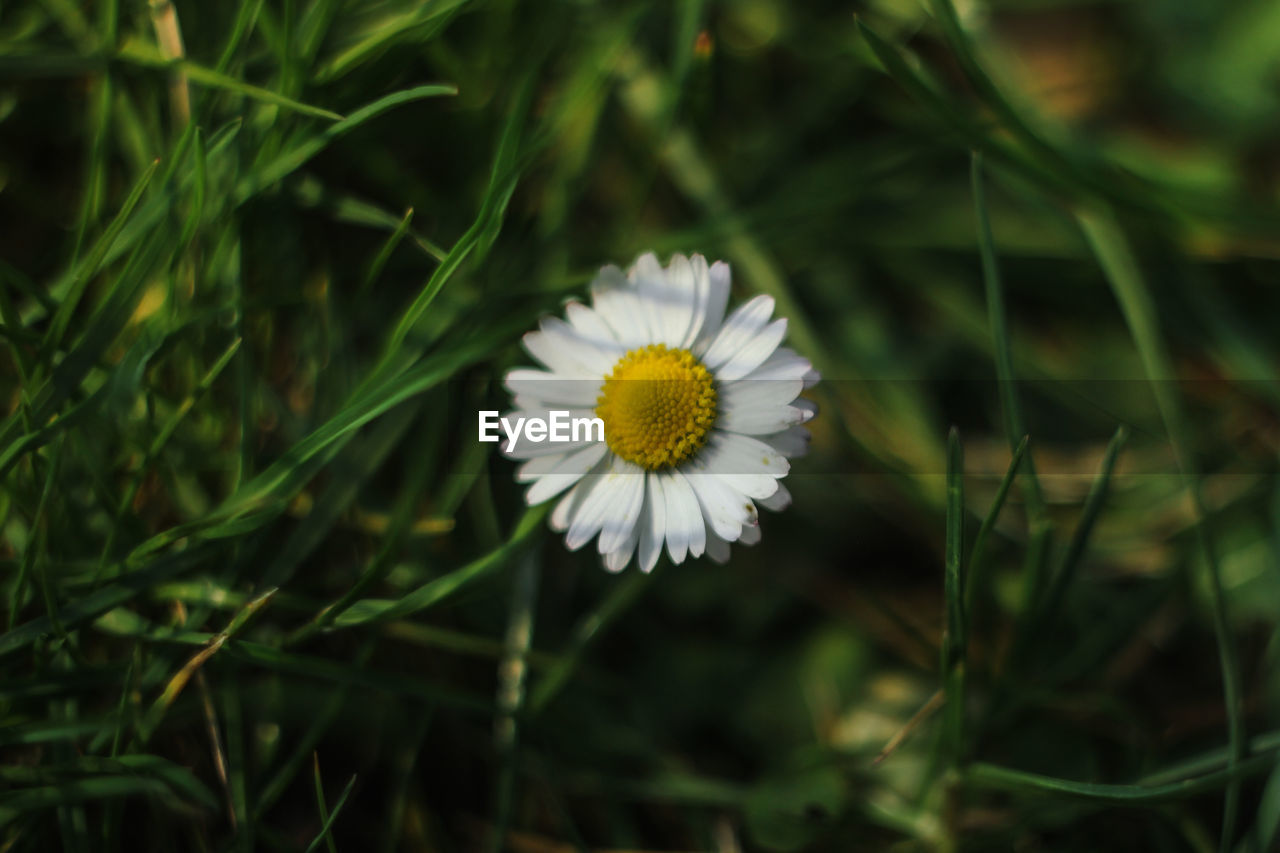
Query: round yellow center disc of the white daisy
595,343,716,471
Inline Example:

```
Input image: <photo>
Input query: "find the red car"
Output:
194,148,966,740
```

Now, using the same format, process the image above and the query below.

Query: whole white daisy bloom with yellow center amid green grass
503,254,818,571
